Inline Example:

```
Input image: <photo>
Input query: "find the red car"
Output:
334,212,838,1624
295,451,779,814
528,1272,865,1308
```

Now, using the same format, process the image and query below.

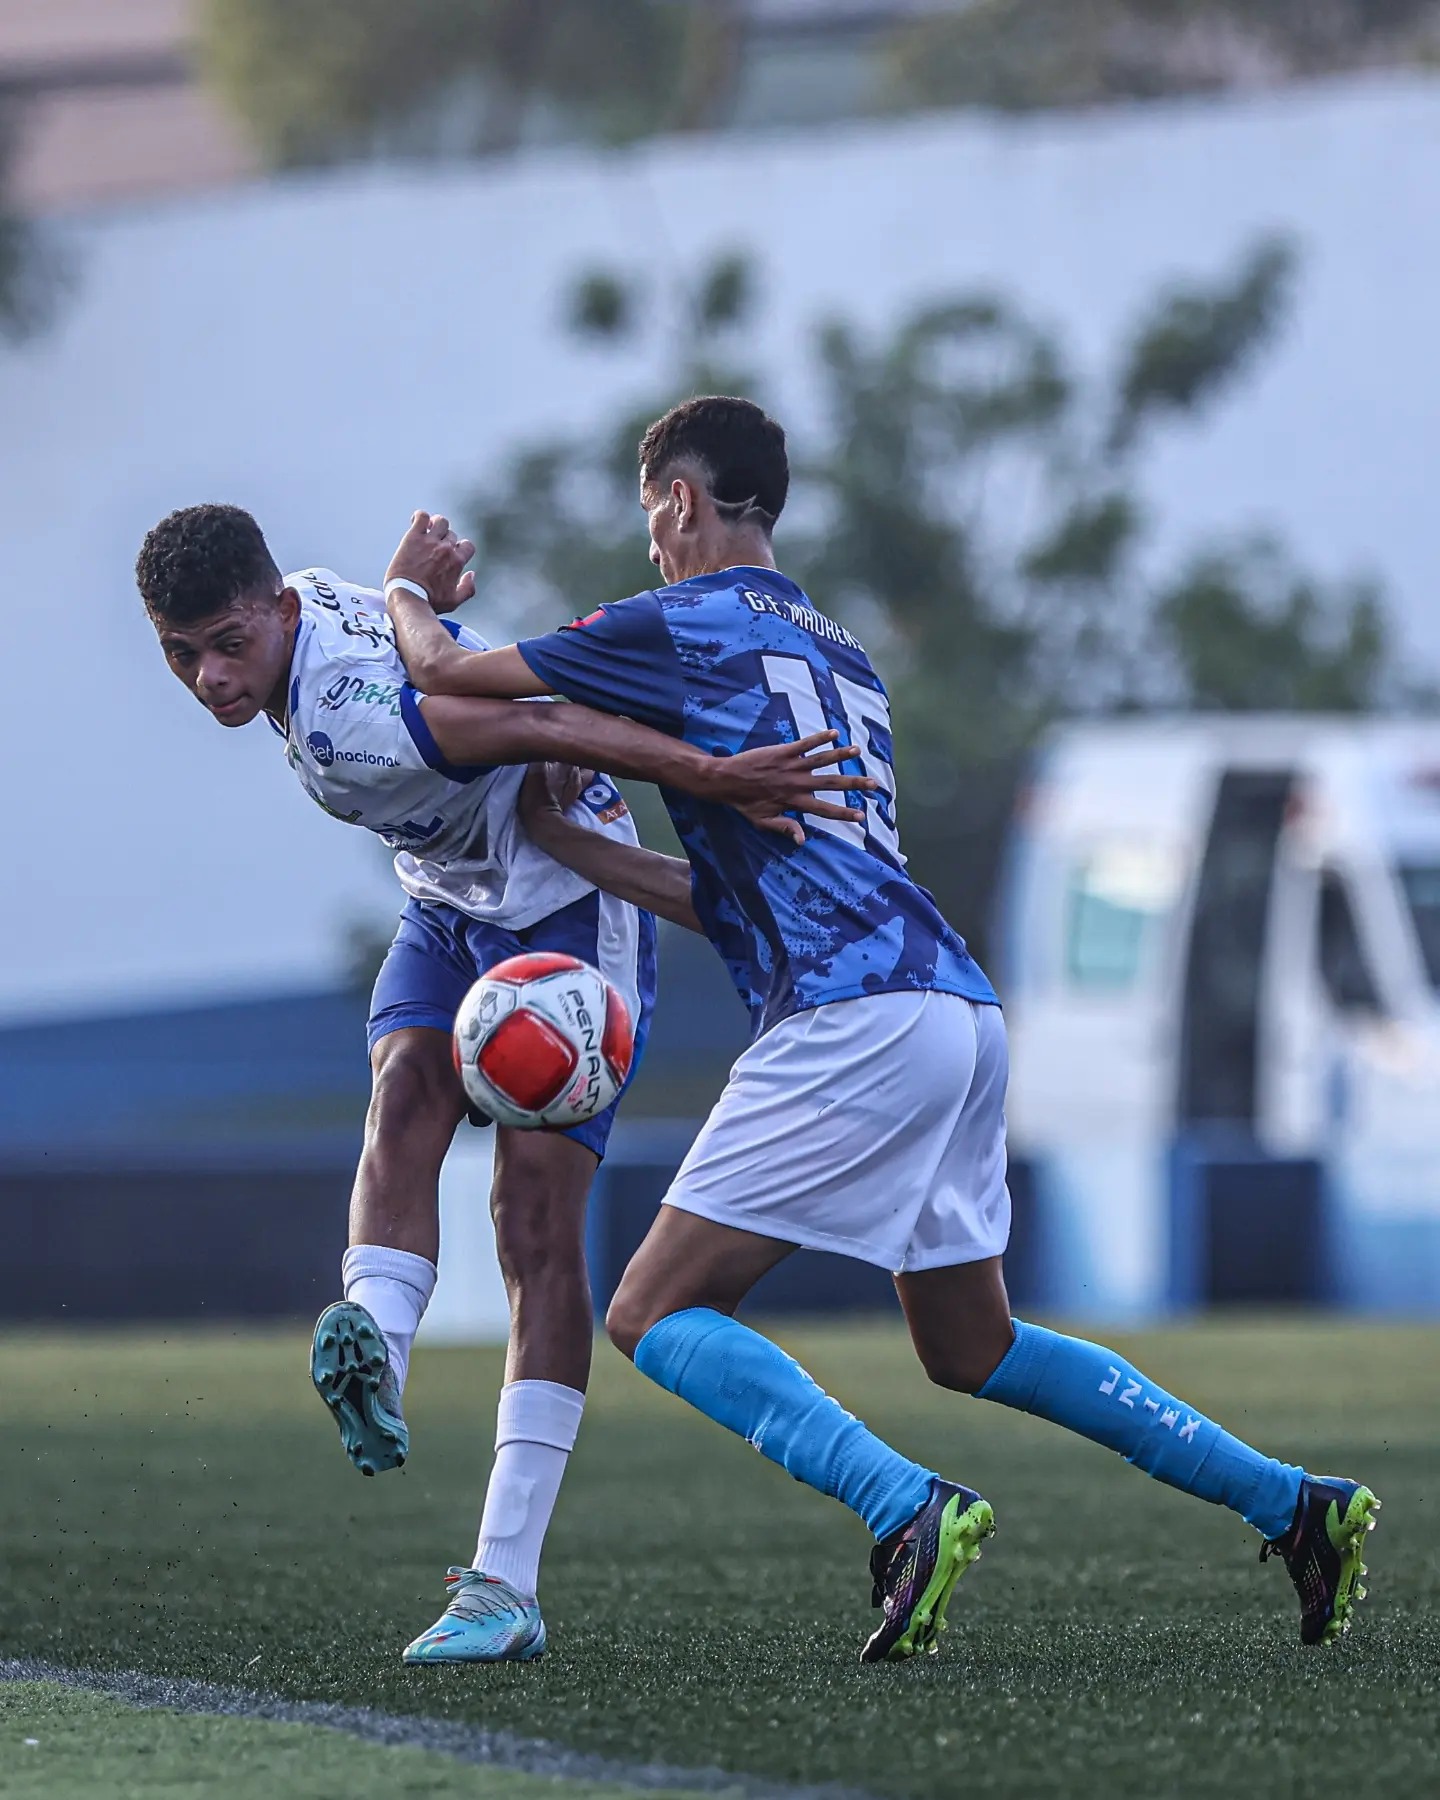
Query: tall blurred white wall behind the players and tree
0,79,1440,1015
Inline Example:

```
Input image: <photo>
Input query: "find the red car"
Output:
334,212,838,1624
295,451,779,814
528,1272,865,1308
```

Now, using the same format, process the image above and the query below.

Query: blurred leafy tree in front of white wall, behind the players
472,241,1399,957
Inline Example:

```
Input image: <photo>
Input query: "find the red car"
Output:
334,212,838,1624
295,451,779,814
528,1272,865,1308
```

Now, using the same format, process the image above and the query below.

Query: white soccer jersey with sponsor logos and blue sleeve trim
284,569,637,931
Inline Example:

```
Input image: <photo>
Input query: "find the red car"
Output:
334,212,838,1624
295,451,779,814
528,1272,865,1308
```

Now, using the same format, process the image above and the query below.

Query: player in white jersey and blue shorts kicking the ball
137,506,855,1661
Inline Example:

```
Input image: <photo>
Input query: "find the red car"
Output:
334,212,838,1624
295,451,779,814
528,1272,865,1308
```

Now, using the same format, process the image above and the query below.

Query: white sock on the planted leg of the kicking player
473,1381,585,1600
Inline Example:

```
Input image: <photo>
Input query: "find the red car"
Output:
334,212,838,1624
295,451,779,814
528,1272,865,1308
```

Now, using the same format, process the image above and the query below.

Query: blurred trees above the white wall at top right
889,0,1440,112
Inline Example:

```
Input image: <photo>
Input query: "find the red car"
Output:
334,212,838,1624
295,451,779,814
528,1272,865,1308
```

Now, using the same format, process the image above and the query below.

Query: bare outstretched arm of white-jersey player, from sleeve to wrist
423,695,724,799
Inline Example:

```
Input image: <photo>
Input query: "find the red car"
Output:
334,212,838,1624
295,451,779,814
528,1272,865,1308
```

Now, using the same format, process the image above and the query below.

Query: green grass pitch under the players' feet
0,1321,1440,1800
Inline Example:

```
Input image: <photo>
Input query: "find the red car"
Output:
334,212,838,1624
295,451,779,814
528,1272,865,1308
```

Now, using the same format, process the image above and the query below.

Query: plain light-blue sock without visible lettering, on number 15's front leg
635,1307,934,1539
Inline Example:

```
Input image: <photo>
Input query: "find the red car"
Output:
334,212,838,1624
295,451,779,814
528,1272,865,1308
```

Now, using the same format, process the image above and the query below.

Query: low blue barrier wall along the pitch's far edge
0,986,1418,1319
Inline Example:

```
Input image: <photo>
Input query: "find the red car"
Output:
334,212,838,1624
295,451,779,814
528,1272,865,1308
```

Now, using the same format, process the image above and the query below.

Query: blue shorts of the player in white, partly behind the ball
365,893,655,1157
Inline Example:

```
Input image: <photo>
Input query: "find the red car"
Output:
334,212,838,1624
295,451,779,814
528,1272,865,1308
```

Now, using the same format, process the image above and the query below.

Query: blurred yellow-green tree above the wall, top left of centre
200,0,738,166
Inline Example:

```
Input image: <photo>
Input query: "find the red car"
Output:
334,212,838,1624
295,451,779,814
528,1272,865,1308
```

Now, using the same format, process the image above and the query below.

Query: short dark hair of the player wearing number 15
641,394,790,531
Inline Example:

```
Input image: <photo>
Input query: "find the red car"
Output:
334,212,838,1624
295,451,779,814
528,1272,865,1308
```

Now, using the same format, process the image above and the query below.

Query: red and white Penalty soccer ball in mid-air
454,950,635,1130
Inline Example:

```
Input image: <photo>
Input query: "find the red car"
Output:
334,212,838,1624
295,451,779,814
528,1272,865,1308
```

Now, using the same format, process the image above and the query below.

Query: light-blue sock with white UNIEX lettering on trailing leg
979,1319,1305,1537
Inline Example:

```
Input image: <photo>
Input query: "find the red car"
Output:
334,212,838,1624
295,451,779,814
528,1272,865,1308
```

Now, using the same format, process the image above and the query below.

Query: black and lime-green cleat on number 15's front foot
860,1481,995,1663
